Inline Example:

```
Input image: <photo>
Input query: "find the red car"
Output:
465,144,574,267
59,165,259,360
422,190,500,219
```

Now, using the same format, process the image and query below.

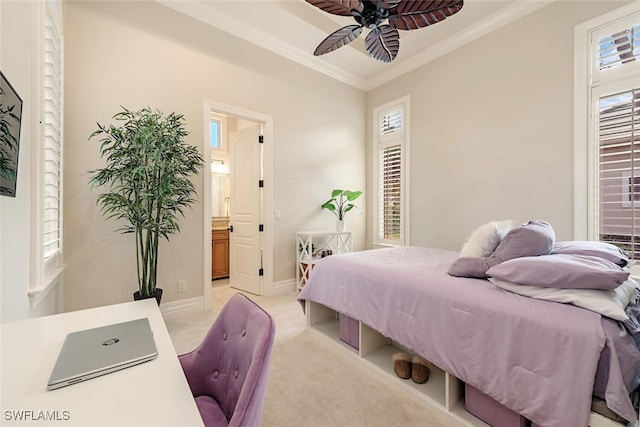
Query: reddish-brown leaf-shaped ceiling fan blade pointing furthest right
389,0,464,30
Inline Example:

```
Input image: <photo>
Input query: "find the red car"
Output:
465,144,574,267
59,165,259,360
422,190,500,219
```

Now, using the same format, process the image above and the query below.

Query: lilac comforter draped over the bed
298,247,640,427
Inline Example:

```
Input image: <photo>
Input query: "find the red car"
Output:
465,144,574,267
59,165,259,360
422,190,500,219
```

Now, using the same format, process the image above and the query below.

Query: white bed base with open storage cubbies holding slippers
305,301,640,427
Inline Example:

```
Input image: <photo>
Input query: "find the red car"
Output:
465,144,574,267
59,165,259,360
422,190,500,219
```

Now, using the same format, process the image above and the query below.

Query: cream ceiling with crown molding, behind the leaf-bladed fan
157,0,553,90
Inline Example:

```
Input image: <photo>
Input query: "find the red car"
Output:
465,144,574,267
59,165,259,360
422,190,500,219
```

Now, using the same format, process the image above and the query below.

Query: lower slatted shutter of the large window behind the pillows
597,88,640,259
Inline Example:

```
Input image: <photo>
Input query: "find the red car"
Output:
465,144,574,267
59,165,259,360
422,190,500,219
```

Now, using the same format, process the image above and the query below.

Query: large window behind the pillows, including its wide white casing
575,4,640,259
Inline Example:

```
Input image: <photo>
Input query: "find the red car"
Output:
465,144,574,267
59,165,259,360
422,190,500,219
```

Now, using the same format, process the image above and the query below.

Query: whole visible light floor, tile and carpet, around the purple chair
165,287,451,427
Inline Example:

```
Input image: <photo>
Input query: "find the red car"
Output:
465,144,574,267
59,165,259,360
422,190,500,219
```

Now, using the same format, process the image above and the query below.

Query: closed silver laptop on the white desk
47,318,158,390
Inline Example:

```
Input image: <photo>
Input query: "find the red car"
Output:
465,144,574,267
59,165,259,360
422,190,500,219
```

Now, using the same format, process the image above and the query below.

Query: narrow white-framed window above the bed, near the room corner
373,97,409,245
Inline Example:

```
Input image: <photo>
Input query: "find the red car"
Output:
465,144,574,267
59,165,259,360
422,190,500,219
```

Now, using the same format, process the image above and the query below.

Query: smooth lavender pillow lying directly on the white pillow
487,254,629,290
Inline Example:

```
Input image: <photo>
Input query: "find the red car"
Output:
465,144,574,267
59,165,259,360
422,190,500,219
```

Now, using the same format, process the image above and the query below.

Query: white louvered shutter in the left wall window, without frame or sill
42,2,62,263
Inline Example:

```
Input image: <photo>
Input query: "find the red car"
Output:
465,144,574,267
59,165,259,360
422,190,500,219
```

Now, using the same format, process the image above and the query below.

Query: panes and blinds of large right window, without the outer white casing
587,12,640,259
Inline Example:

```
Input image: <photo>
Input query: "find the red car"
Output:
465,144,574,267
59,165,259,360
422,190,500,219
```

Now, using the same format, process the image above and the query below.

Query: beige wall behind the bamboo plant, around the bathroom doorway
64,1,366,310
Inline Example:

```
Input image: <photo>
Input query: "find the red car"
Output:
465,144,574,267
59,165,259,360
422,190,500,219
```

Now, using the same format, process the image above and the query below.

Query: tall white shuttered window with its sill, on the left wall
29,0,63,305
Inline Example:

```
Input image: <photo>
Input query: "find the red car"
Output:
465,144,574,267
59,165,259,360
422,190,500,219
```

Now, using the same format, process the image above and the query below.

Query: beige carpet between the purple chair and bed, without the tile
262,331,449,426
